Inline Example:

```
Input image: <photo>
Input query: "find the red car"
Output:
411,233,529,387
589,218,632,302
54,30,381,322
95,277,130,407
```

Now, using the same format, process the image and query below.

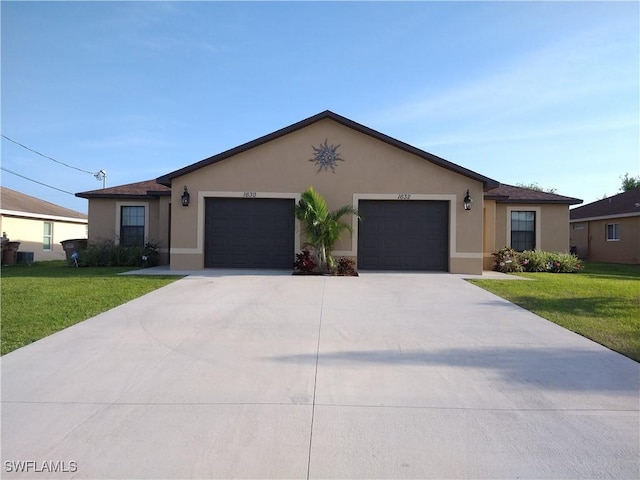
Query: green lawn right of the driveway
472,263,640,362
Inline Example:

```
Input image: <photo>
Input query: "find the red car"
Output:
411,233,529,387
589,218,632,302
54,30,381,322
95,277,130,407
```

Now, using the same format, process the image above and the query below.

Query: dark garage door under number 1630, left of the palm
204,198,295,269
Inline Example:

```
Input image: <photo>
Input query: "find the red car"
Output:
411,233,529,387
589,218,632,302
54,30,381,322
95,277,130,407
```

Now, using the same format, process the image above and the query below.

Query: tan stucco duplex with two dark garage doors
77,111,581,274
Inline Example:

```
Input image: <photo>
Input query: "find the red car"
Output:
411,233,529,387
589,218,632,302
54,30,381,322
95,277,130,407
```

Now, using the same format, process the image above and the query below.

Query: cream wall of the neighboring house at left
0,216,87,262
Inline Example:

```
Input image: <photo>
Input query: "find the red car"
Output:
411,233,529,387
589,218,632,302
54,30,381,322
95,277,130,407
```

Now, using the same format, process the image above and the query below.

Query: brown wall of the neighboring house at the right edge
571,216,640,264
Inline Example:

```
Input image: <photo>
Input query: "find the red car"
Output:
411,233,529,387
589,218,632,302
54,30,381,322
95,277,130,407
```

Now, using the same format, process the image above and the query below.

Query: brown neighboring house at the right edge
570,188,640,264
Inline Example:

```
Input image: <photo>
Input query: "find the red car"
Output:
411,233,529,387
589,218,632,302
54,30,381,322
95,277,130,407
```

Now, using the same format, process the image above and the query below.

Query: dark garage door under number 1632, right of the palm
358,200,449,272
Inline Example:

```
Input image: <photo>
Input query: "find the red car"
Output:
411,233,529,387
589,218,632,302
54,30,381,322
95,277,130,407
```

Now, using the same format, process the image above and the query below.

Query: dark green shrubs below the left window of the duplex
77,240,158,267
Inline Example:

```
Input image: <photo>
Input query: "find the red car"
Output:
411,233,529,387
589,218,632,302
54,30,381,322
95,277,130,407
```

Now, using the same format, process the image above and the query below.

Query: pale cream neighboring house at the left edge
0,187,88,261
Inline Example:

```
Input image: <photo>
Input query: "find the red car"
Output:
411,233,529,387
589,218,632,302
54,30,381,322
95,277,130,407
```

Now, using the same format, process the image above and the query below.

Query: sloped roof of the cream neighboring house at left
0,187,88,223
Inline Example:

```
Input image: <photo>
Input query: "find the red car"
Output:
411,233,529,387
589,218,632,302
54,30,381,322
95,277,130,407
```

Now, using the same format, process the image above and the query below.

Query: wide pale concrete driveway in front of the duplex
2,272,640,479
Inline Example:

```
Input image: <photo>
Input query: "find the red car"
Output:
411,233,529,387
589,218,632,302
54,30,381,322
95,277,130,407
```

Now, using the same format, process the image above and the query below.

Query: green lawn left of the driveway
0,261,180,355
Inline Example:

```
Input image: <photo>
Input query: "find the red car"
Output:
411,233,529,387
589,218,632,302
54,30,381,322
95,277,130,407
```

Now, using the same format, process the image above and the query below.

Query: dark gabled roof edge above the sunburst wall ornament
157,110,499,190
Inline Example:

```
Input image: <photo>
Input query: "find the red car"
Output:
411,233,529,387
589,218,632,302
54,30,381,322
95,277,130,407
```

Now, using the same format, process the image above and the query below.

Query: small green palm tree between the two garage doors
295,187,360,270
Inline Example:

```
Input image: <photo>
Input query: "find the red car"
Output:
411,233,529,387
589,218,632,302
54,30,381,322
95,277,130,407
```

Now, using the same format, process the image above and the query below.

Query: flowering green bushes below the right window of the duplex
493,247,582,273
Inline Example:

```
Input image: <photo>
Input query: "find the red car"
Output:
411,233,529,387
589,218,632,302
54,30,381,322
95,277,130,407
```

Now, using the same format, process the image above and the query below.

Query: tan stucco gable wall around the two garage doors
171,119,483,273
